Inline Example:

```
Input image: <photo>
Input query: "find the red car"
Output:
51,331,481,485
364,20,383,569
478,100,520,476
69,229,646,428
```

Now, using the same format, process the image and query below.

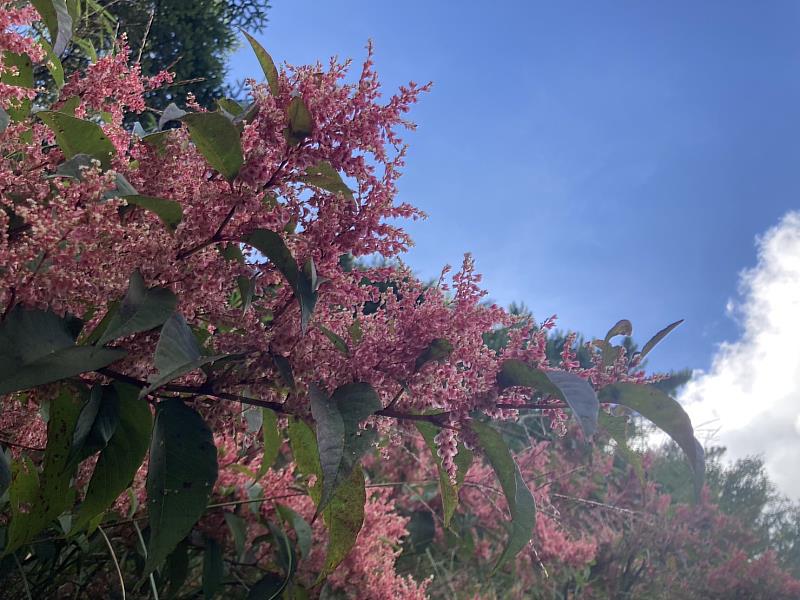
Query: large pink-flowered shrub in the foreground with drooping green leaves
0,0,703,598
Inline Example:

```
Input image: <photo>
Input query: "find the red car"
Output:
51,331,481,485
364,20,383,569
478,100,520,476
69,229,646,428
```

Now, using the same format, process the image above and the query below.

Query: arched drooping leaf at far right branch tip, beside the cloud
600,383,705,496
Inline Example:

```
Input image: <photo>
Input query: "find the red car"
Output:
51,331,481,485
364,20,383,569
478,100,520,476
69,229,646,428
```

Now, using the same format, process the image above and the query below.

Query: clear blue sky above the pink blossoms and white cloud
230,0,800,370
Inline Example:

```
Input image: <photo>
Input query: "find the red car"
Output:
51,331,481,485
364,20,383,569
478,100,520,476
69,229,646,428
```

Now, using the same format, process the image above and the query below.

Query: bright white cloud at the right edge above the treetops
679,212,800,499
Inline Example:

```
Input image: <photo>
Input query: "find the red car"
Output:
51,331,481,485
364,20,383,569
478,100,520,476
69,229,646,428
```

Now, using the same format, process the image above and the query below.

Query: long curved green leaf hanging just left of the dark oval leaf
72,383,153,532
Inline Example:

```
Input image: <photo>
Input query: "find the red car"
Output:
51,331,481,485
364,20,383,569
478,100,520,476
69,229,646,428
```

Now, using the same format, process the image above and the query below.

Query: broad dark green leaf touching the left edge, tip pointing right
0,305,126,396
